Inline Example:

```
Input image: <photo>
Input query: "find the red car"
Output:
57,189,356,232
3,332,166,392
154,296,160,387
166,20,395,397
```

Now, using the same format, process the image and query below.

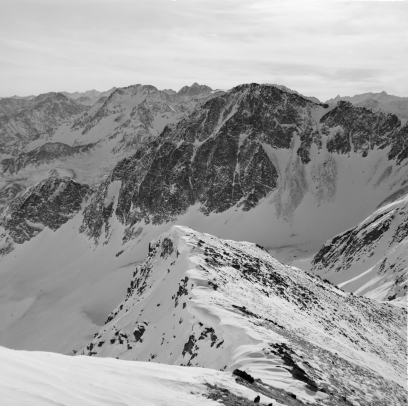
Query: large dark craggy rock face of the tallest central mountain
82,84,321,237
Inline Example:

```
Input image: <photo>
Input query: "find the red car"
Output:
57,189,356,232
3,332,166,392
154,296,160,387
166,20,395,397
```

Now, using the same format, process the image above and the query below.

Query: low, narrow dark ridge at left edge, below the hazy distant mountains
0,142,94,174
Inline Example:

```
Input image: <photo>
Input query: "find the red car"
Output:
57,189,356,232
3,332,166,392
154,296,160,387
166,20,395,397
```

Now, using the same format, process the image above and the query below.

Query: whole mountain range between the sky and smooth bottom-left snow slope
0,83,408,406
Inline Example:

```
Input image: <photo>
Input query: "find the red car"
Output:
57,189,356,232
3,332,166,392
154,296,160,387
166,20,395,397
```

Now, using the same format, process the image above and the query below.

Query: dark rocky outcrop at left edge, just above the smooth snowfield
0,178,91,255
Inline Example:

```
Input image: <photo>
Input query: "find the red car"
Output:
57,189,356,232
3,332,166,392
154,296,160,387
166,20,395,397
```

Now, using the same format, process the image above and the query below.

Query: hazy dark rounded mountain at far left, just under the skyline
0,93,88,155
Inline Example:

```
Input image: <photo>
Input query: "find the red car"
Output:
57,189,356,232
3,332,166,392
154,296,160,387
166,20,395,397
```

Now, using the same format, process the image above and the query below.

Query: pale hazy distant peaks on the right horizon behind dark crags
326,92,408,121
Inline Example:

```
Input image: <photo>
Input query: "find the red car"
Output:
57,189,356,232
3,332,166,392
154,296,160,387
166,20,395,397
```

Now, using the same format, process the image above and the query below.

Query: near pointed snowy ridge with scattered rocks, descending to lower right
81,226,406,405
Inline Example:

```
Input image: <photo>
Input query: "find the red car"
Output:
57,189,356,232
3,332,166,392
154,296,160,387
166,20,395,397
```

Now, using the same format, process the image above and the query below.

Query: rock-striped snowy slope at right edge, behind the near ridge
312,195,408,306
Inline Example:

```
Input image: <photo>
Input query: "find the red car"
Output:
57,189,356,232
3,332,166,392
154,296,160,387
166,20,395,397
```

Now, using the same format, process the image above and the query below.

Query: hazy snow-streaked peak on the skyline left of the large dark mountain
58,85,215,150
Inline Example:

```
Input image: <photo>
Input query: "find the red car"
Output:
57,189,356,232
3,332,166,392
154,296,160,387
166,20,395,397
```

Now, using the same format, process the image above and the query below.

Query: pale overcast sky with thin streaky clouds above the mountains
0,0,408,100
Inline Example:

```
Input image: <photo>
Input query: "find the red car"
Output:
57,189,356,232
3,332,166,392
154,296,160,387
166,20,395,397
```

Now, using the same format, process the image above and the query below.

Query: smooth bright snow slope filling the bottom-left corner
0,347,278,406
